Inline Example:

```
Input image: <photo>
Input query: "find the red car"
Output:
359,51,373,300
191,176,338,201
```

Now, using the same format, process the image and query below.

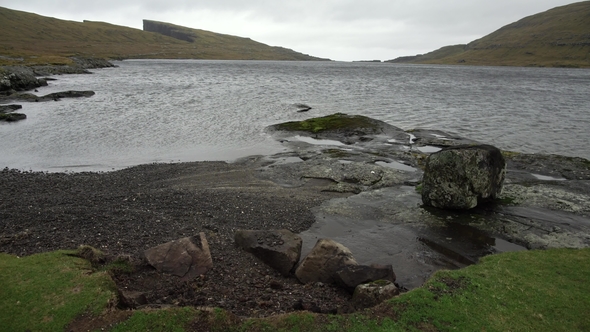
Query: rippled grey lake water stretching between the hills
0,60,590,171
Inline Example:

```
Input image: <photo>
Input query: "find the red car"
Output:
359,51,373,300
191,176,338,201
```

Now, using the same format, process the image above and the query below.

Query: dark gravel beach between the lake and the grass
0,158,350,317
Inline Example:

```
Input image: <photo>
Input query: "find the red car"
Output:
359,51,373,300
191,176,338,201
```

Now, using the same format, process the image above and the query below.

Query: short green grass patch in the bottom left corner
0,251,116,331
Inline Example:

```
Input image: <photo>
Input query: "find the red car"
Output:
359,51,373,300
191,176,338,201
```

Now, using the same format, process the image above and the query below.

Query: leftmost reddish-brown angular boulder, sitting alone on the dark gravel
144,232,213,281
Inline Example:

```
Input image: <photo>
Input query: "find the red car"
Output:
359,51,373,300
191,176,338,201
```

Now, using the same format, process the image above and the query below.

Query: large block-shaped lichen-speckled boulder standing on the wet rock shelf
422,145,506,209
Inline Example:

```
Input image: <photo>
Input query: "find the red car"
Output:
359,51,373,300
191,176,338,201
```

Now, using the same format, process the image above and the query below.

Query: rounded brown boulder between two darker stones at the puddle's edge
295,239,358,284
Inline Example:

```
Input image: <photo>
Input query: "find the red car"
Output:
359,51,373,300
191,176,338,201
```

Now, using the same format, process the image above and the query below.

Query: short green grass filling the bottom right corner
390,249,590,331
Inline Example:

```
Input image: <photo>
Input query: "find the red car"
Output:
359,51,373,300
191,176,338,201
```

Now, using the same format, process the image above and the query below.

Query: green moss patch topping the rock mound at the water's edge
273,113,381,134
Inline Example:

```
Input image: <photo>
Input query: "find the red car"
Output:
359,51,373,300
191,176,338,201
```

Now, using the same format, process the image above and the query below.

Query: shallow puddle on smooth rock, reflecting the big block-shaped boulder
300,187,526,289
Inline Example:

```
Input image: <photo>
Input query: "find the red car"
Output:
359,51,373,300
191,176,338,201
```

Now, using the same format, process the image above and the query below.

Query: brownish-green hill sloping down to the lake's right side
387,1,590,67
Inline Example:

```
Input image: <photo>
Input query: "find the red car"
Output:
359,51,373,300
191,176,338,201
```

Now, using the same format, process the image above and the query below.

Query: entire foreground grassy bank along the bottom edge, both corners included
0,248,590,332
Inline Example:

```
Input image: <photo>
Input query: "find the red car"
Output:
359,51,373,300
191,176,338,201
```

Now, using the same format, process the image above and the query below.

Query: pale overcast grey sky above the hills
0,0,577,61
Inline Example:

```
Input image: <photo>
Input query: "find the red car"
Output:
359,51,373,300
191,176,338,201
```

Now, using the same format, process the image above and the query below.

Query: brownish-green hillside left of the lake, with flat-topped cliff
0,7,327,64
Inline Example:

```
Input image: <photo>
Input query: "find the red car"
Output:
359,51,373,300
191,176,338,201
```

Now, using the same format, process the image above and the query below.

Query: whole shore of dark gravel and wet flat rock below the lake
0,113,590,317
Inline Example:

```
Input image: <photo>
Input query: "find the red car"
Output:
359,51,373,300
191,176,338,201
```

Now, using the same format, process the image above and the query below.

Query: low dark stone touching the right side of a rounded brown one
334,264,395,293
